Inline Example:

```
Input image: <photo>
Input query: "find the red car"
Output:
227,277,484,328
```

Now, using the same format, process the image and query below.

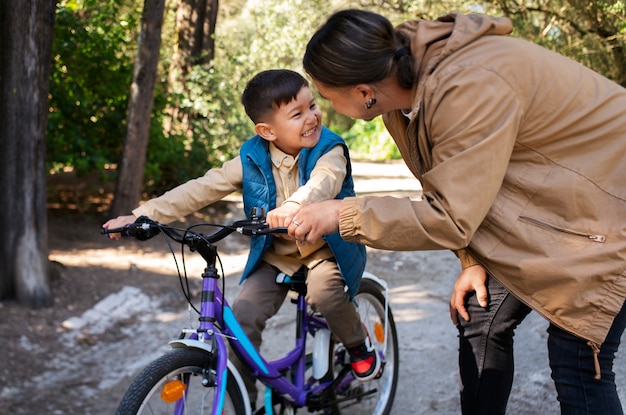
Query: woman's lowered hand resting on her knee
450,265,489,324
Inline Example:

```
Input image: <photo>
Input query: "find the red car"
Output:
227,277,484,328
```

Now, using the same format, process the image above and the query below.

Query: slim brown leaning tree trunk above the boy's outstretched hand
111,0,165,216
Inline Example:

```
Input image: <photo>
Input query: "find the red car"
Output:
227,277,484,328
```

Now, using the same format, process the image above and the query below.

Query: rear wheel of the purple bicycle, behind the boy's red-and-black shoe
336,278,399,415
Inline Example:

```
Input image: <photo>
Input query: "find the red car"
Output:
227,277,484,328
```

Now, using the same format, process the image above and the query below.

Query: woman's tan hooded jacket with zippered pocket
340,14,626,348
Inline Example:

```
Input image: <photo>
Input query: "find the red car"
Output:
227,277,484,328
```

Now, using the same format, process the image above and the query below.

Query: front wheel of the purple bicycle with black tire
117,349,246,415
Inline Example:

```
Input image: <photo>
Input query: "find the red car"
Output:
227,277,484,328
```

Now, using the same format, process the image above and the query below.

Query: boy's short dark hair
241,69,309,124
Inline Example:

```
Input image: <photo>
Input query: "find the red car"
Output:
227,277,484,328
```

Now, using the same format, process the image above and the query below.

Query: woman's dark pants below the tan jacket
458,277,626,415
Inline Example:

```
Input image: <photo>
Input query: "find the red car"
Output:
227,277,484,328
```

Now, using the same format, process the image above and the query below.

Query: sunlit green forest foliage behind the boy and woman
0,0,626,305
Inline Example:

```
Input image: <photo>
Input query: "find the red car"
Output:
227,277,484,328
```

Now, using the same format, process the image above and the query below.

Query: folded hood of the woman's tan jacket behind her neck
396,13,513,79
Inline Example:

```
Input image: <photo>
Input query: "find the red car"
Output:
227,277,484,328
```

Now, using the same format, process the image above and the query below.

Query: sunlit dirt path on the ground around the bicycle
0,165,626,415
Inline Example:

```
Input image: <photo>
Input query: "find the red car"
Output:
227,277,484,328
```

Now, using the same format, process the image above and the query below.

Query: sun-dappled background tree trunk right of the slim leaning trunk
163,0,219,136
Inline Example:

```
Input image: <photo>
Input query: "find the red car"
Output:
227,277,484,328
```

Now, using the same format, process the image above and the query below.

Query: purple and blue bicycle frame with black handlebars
102,218,397,415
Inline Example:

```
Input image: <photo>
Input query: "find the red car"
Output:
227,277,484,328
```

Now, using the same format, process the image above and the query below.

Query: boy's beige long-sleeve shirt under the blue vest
133,143,347,274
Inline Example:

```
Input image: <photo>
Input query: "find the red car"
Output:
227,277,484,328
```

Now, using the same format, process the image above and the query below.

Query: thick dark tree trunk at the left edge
0,0,56,307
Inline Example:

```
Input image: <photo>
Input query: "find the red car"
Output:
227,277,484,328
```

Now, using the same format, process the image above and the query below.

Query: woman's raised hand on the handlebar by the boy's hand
288,199,341,244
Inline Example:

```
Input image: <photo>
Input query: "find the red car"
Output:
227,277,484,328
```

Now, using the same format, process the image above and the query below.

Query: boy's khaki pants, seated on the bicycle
229,261,366,402
